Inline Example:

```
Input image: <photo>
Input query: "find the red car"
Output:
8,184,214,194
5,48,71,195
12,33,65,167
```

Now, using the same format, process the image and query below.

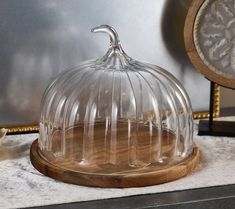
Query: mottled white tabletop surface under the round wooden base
0,118,235,208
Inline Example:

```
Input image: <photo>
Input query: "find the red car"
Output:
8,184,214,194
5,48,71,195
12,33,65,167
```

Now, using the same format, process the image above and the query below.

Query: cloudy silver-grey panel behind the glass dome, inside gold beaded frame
0,0,213,126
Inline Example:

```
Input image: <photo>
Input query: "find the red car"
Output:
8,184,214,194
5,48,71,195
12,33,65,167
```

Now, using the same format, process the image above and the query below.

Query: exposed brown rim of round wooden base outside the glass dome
30,140,200,188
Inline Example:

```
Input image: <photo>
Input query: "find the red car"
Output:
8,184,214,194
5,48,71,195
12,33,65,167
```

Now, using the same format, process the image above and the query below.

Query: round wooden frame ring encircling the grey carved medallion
184,0,235,89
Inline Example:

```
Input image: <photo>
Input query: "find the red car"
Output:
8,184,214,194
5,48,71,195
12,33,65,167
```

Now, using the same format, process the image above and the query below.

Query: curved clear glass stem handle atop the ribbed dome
91,25,120,48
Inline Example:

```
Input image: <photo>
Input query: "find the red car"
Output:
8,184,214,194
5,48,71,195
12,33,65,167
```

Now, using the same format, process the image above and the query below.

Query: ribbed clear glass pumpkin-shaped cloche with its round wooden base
31,25,199,187
